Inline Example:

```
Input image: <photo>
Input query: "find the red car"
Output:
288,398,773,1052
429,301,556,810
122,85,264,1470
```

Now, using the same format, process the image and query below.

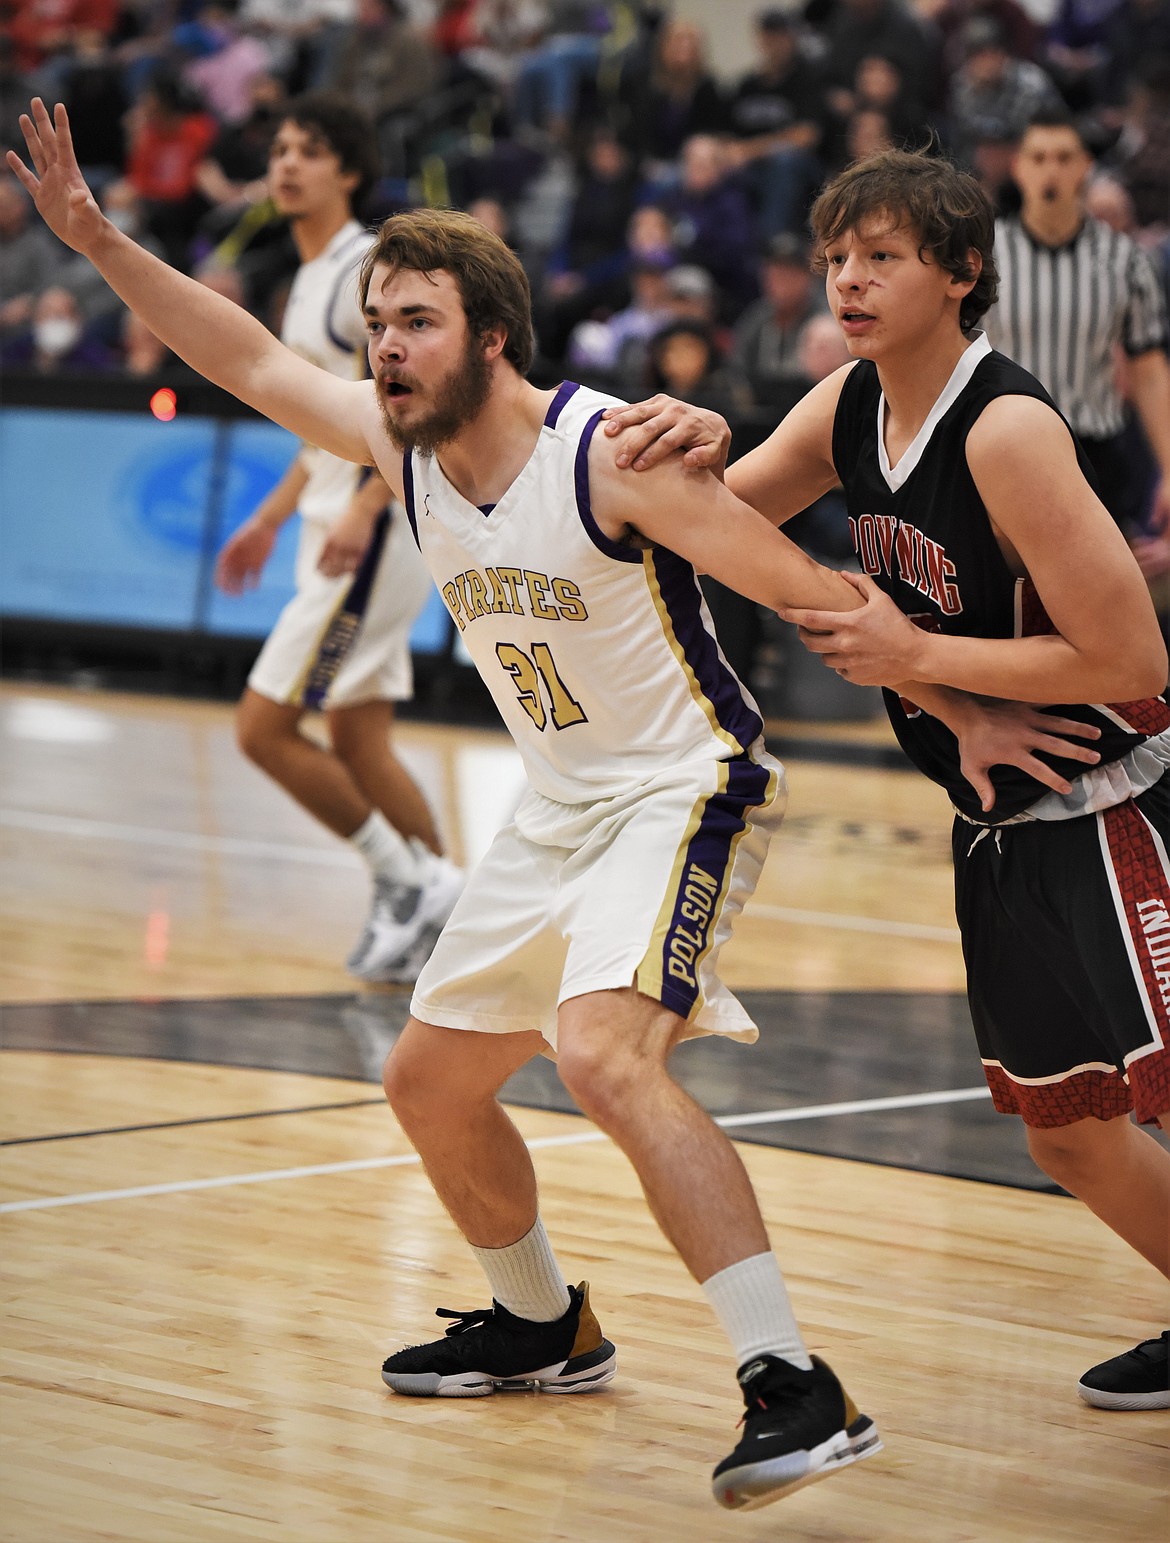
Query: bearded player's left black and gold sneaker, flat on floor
381,1281,617,1398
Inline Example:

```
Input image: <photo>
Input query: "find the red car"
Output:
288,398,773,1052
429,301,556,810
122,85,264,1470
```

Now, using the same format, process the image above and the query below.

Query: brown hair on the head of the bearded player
358,208,536,375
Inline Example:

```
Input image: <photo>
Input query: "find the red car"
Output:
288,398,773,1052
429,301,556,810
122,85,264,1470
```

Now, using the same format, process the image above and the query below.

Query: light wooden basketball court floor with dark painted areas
0,685,1170,1543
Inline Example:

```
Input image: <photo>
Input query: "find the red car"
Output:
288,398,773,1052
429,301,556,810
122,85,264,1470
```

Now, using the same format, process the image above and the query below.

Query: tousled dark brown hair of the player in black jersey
809,150,999,332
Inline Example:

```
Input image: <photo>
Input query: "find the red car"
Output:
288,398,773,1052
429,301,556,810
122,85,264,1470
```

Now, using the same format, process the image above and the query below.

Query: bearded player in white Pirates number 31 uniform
8,100,932,1509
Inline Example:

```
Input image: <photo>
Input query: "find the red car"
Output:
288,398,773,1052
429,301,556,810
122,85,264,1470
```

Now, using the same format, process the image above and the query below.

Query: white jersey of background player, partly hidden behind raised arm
281,219,374,523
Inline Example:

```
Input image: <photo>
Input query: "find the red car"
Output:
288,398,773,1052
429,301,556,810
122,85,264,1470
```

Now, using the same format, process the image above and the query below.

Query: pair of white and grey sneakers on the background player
346,841,466,984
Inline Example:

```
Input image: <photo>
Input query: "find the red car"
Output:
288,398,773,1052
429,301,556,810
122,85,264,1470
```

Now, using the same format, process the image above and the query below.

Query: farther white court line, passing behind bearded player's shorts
0,809,959,943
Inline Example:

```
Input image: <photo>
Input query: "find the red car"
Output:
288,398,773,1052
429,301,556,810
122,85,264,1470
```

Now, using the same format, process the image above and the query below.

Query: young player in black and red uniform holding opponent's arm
607,151,1170,1409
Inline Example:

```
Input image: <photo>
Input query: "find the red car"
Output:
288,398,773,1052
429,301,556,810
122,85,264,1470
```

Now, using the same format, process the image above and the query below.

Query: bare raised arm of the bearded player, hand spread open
6,97,378,475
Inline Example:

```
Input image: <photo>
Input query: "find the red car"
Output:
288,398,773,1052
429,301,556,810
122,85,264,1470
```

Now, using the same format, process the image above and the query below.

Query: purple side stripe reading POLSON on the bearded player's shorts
661,756,770,1018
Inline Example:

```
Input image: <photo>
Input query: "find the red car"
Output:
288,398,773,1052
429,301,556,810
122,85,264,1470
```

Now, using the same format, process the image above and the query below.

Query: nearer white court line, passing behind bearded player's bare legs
0,1086,991,1216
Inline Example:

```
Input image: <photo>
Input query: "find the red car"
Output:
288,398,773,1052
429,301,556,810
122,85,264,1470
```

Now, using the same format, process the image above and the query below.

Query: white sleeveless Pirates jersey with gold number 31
403,384,763,804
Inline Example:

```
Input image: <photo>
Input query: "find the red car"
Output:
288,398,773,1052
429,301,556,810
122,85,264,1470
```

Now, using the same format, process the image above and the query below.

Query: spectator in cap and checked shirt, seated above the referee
948,17,1060,167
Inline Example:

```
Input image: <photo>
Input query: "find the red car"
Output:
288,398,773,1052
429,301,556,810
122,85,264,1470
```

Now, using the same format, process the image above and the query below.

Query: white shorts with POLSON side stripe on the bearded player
411,742,787,1049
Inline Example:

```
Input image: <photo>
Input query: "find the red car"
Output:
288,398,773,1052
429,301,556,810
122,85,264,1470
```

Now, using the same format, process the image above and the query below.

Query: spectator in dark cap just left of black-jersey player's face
732,235,824,410
